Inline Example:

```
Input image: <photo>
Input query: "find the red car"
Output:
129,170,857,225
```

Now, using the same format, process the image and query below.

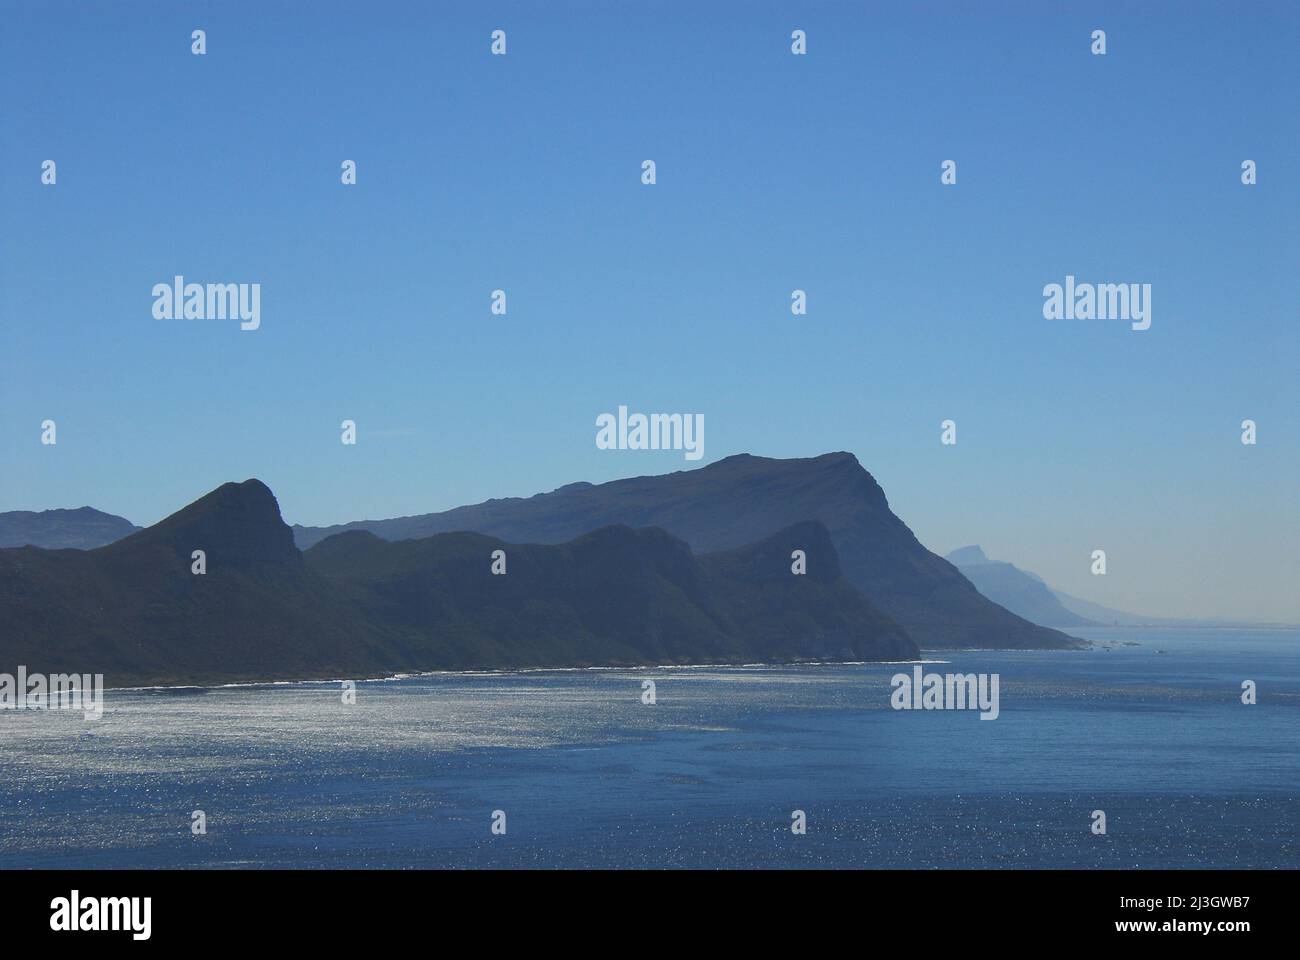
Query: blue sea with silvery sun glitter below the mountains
0,628,1300,868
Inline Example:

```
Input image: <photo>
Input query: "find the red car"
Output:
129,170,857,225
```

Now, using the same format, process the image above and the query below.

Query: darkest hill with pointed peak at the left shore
0,480,406,684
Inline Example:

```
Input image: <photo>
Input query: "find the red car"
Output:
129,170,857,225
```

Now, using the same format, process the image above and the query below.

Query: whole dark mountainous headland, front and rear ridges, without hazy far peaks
0,453,1083,686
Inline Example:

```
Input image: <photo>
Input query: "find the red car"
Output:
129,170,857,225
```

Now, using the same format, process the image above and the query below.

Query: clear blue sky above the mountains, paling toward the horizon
0,0,1300,620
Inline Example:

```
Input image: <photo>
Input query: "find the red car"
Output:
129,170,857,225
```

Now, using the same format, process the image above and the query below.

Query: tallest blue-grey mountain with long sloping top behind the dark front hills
294,453,1082,648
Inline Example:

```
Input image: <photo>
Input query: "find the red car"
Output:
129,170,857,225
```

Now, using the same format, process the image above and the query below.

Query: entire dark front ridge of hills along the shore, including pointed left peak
0,480,918,686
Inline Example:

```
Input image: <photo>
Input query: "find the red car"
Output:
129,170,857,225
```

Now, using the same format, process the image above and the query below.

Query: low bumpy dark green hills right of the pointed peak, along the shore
304,523,918,669
